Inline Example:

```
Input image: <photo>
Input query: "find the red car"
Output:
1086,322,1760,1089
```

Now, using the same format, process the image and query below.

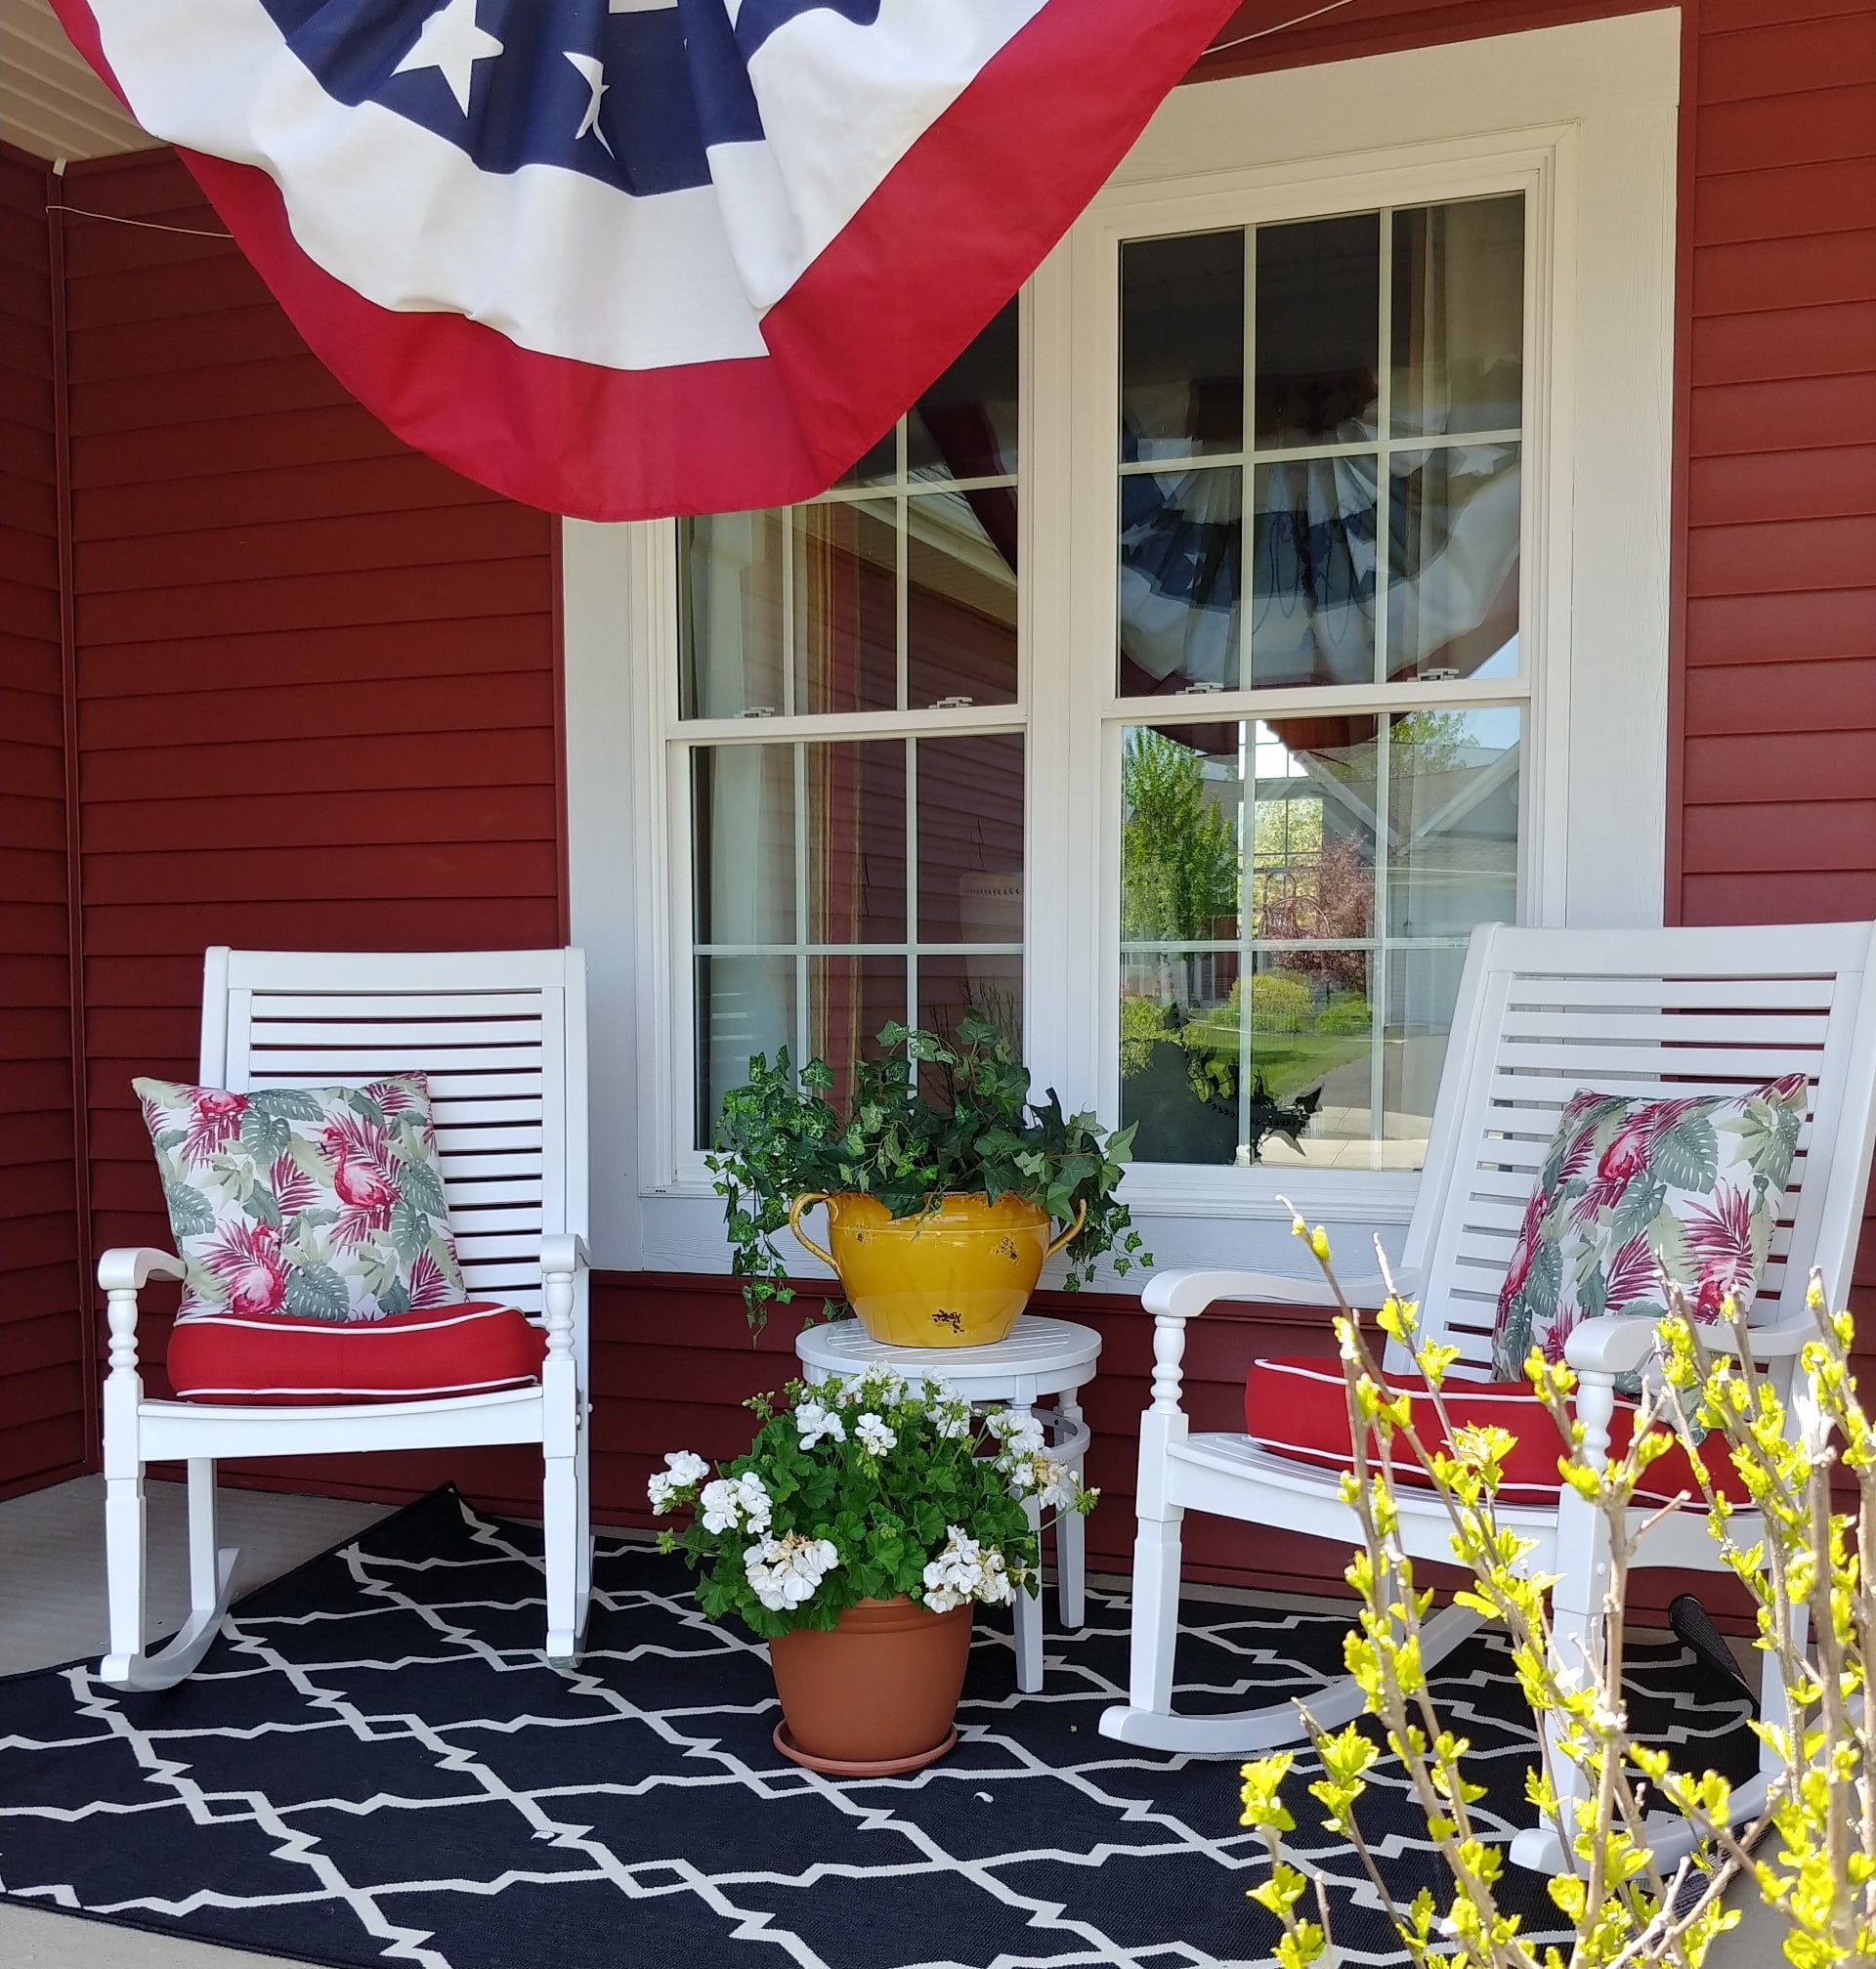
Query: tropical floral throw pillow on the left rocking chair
132,1073,464,1321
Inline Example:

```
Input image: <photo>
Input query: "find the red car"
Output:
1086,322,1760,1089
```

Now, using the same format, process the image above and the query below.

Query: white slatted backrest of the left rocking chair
200,949,586,1323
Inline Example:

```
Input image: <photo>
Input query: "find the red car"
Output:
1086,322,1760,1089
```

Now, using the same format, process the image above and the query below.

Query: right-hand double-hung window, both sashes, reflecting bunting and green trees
1106,191,1529,1170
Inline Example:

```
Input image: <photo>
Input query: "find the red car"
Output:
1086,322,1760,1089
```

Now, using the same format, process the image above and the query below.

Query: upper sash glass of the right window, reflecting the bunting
1116,197,1523,697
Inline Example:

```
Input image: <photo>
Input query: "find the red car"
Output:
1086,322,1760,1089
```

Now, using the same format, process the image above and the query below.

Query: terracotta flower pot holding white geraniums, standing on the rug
768,1593,970,1776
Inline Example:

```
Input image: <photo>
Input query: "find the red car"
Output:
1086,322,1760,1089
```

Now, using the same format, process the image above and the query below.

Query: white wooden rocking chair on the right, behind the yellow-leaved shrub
1100,923,1876,1870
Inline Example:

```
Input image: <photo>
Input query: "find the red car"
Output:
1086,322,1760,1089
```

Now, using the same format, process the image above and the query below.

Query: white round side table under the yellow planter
795,1313,1100,1695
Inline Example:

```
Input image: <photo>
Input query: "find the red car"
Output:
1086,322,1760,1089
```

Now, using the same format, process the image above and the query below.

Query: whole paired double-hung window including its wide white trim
567,16,1676,1270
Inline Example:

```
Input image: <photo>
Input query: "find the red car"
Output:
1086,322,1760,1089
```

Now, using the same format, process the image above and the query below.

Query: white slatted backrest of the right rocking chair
1389,923,1876,1376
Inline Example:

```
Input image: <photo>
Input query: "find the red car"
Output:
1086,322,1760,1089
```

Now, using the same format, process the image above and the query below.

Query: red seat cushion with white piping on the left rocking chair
169,1300,547,1404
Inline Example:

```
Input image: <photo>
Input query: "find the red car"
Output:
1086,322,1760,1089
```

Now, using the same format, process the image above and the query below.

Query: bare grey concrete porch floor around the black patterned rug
0,1477,1781,1969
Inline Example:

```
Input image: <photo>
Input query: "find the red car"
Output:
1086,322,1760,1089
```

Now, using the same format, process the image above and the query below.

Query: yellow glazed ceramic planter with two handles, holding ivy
788,1189,1087,1347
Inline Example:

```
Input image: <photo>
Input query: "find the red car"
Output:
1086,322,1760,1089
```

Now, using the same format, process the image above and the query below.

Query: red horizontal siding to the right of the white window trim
1669,0,1876,1465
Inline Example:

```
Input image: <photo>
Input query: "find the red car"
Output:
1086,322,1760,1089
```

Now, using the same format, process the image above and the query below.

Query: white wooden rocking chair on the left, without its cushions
99,947,592,1690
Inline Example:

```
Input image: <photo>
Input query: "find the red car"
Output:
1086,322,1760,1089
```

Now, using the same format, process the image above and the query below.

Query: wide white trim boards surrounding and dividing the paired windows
561,10,1680,1274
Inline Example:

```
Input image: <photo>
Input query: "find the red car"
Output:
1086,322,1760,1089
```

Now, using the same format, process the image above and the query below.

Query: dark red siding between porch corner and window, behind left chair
58,151,565,1488
